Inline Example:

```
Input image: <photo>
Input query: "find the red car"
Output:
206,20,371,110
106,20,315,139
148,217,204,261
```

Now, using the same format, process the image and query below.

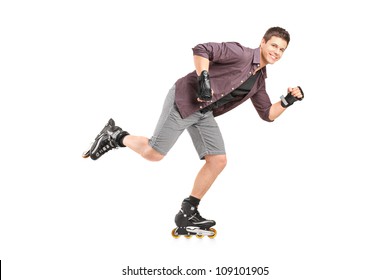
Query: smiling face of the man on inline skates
260,36,287,65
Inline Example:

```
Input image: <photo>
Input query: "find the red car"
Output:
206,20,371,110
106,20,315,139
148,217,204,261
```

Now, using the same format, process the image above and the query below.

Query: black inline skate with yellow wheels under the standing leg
172,199,217,238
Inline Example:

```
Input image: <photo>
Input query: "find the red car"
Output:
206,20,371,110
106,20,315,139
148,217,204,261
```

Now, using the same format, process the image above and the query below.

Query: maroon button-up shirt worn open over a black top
175,42,272,121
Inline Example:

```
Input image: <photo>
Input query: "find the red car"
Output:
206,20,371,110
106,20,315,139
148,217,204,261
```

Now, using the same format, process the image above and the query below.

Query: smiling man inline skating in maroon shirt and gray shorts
84,27,303,237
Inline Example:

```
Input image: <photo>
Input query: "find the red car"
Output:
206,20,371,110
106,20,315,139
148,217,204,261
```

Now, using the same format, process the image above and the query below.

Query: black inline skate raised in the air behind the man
82,119,129,160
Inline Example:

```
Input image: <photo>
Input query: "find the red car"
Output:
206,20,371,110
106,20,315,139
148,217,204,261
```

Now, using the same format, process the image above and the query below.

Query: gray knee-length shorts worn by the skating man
149,86,226,159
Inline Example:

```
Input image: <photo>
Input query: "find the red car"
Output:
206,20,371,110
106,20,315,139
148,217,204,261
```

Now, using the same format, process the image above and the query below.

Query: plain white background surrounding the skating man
0,0,390,280
